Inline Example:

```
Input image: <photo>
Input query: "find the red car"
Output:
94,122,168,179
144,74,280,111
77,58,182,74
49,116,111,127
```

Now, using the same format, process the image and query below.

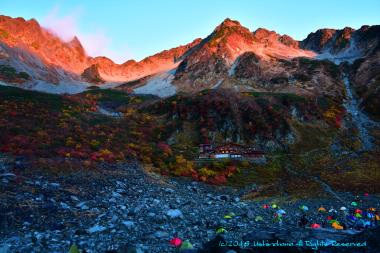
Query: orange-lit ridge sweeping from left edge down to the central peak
0,16,200,83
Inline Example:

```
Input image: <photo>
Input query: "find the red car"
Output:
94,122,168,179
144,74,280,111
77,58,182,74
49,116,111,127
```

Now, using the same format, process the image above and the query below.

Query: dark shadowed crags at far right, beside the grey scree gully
300,25,380,119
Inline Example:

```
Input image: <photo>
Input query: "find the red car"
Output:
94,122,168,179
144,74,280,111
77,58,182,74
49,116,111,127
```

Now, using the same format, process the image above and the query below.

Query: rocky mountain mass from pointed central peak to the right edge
135,19,379,97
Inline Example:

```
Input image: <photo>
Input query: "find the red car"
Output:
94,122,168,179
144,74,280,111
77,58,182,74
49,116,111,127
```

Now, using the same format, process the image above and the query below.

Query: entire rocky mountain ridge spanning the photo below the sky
0,16,380,105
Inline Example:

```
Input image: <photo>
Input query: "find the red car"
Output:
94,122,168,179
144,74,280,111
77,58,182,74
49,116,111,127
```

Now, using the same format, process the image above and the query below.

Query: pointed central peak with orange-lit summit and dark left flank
175,19,314,90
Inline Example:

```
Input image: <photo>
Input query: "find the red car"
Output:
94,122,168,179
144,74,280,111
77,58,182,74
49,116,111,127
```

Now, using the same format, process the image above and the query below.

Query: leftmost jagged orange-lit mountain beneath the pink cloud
0,16,87,84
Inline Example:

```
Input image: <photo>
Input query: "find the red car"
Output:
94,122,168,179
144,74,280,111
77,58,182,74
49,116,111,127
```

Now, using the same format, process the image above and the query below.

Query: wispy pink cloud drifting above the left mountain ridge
41,7,132,63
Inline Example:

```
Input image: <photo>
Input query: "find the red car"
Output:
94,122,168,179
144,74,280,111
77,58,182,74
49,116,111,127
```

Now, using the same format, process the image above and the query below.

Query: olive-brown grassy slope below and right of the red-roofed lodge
230,115,380,199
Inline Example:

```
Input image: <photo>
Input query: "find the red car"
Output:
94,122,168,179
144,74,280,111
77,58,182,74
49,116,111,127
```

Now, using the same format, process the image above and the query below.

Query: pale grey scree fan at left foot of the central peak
134,70,176,98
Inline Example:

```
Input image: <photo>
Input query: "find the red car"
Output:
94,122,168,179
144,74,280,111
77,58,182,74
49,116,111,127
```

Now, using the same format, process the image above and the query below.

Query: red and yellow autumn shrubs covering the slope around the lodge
0,87,344,184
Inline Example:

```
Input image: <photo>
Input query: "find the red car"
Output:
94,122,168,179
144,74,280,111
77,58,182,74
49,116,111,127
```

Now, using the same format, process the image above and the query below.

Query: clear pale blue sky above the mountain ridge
0,0,380,63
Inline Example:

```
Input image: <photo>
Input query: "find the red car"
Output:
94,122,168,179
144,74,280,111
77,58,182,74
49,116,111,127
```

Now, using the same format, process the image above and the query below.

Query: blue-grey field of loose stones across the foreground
0,159,380,253
